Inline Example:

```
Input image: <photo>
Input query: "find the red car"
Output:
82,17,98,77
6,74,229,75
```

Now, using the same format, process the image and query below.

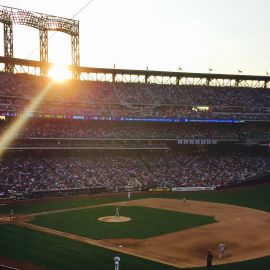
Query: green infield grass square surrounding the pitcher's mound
30,206,215,239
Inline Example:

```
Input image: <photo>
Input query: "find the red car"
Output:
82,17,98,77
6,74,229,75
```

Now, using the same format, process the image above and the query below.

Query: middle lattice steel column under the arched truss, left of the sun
39,29,48,77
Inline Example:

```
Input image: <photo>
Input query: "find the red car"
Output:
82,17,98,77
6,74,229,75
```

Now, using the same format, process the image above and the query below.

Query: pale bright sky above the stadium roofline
0,0,270,75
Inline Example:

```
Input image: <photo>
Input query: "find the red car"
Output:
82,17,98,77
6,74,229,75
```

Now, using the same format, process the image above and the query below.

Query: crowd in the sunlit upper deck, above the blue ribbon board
0,73,270,120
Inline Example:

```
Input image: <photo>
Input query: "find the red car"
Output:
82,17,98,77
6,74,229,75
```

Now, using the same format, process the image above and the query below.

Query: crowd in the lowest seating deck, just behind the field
0,153,270,194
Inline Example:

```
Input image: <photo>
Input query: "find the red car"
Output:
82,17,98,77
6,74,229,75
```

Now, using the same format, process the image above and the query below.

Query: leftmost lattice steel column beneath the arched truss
4,23,14,72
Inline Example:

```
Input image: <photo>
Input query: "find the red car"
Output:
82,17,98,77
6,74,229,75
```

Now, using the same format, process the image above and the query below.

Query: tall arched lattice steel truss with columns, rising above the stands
0,5,80,79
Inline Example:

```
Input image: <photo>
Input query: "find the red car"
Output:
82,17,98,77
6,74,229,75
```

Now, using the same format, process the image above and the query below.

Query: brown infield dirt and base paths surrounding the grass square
0,187,270,269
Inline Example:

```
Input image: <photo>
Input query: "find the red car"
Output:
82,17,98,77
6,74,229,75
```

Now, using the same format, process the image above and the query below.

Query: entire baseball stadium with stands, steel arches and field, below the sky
0,0,270,270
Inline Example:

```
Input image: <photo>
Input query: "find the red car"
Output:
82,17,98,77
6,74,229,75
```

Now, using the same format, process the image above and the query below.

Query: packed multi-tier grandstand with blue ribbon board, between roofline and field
0,67,270,197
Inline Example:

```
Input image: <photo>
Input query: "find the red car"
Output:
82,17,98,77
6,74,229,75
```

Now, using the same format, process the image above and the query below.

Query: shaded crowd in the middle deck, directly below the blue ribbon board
0,119,238,140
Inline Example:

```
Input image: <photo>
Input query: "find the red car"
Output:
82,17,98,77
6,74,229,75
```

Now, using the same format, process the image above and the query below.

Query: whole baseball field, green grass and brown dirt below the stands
0,185,270,270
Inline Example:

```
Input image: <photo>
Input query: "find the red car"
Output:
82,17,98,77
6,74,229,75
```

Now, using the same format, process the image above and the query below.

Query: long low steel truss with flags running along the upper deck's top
0,56,270,89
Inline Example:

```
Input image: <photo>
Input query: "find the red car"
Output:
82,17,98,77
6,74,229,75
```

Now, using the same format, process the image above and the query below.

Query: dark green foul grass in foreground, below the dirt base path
0,225,270,270
